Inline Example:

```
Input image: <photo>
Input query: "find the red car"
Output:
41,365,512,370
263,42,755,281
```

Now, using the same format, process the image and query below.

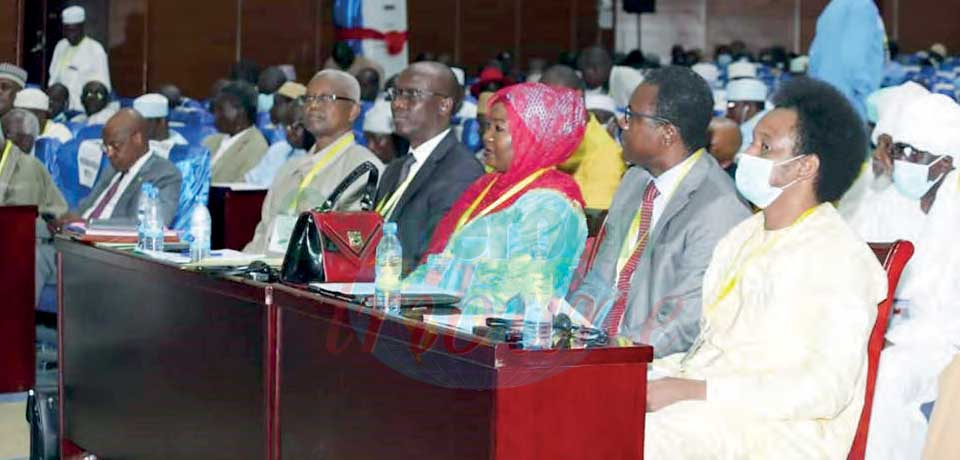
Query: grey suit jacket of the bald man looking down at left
77,154,182,227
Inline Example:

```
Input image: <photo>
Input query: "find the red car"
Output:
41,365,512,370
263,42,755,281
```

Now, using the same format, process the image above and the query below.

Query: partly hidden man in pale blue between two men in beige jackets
244,95,316,187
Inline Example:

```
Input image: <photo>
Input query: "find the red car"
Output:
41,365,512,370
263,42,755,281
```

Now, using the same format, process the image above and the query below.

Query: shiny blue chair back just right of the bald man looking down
170,145,210,230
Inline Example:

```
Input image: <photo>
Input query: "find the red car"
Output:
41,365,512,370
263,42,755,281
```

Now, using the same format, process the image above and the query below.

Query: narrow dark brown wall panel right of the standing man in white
107,0,149,96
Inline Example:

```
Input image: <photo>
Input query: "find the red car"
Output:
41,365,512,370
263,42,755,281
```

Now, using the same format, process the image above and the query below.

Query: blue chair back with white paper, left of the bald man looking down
50,138,109,209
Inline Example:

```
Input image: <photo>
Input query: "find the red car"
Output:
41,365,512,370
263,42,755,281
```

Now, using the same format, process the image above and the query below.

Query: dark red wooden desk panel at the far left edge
0,206,37,393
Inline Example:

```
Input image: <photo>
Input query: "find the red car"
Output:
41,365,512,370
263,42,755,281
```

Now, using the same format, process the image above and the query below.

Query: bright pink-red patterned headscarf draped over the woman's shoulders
424,83,587,258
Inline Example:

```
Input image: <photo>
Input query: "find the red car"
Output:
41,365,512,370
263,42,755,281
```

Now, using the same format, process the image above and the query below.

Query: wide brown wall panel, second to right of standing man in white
147,0,238,98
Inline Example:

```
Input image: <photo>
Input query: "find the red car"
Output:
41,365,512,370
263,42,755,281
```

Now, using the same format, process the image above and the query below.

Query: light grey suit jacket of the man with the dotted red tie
571,154,750,357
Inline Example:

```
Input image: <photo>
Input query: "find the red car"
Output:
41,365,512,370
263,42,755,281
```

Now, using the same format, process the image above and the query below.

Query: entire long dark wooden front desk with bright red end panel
56,239,652,460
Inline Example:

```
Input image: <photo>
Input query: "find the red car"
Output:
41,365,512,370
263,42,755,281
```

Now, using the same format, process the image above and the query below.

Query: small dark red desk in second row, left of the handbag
209,187,267,251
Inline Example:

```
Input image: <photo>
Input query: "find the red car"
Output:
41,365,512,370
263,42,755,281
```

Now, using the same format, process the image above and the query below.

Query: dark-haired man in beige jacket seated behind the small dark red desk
203,81,268,183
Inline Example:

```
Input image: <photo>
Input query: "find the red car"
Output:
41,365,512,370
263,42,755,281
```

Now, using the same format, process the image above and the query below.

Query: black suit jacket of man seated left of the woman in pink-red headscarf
377,130,483,273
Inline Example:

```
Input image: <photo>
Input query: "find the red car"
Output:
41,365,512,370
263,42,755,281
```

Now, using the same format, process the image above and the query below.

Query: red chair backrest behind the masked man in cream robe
847,240,913,460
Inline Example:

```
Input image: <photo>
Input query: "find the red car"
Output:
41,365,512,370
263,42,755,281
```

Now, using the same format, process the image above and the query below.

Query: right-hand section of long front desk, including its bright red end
273,287,652,460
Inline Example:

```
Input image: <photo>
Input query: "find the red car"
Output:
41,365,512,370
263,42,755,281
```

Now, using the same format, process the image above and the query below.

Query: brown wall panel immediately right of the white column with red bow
407,0,462,64
